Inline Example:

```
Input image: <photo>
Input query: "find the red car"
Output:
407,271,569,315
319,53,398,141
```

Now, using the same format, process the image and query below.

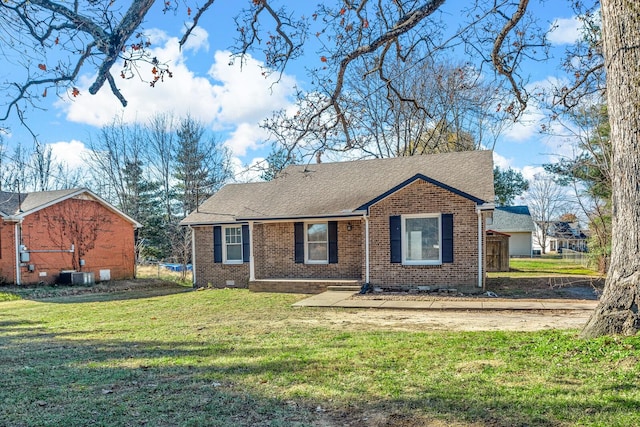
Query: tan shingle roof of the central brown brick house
182,151,494,225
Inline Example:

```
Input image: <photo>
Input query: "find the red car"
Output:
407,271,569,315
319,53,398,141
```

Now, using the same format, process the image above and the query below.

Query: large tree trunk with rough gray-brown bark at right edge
582,0,640,338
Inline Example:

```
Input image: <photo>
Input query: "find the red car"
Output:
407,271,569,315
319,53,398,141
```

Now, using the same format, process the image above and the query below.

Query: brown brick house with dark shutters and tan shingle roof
182,151,494,293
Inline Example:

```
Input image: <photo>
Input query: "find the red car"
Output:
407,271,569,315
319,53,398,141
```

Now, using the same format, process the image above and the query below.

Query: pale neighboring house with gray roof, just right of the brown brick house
489,206,536,257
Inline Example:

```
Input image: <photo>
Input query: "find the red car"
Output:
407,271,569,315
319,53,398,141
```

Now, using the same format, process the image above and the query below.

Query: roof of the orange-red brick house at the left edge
0,188,142,227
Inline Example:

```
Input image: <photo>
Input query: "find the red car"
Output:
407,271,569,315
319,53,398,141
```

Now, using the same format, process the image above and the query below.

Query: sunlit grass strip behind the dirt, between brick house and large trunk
488,257,598,277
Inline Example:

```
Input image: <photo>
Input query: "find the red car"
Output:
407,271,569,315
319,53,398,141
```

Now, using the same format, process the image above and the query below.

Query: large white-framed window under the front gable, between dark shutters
401,214,442,265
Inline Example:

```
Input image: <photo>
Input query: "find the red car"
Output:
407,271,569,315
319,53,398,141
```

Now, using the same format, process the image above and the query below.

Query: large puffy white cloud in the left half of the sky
56,28,295,160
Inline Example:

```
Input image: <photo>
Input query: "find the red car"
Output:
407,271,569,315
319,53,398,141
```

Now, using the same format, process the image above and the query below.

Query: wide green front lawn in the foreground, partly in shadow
0,287,640,426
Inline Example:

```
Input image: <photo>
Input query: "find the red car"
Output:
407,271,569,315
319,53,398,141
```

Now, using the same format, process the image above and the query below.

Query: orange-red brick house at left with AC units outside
0,189,140,285
